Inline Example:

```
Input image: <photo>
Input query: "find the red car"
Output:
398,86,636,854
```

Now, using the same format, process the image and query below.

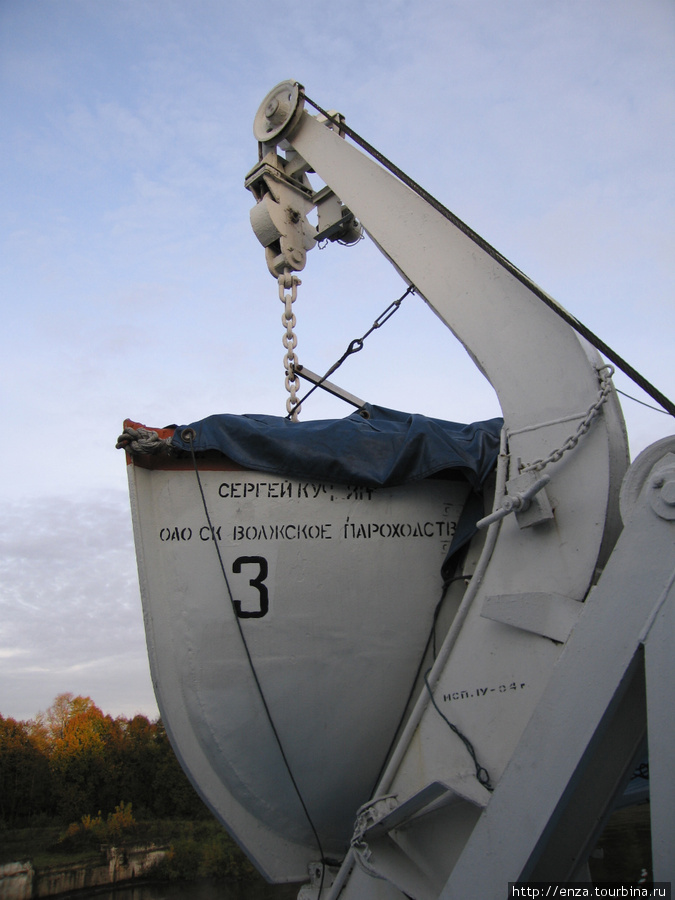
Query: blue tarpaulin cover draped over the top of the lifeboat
171,404,503,488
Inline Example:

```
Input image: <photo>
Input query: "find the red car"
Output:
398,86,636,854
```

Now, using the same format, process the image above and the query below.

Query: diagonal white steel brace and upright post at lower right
440,441,675,900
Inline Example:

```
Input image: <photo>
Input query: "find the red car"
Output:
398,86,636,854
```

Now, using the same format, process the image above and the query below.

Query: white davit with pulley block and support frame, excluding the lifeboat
247,82,675,900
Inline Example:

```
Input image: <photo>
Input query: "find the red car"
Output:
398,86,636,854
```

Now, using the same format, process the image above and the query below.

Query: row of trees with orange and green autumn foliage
0,693,210,828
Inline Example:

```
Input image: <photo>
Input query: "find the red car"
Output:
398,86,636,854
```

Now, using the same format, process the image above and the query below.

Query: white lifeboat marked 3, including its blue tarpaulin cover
120,406,502,880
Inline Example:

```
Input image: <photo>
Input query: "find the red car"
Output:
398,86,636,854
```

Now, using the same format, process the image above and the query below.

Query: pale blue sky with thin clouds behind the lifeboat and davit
0,0,675,719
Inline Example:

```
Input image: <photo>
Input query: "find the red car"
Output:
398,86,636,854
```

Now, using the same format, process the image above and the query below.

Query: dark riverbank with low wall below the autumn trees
0,803,651,900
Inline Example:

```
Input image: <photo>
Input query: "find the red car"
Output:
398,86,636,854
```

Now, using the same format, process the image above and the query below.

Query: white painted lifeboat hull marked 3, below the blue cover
129,462,468,881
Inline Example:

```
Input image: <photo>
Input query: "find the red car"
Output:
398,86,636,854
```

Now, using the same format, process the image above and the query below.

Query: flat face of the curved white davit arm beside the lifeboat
250,91,627,900
